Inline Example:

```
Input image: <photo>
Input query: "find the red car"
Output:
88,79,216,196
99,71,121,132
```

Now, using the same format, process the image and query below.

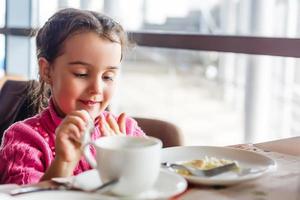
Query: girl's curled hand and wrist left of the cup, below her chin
55,110,91,165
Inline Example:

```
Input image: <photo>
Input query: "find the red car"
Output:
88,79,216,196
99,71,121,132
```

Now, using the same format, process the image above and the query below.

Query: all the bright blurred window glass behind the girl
0,0,300,145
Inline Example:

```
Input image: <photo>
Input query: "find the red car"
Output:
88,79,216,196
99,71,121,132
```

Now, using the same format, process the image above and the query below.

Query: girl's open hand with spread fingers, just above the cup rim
99,113,126,136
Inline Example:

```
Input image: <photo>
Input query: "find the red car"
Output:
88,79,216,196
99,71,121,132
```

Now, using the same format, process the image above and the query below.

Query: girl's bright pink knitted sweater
0,103,144,185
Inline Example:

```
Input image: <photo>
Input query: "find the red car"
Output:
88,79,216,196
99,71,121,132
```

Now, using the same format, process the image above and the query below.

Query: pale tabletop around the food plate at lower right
173,137,300,200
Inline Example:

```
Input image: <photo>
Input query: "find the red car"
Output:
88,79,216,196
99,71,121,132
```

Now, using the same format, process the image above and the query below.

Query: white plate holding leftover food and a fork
162,146,276,186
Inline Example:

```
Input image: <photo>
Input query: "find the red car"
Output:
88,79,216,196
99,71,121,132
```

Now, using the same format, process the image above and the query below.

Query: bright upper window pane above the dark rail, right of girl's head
104,0,300,37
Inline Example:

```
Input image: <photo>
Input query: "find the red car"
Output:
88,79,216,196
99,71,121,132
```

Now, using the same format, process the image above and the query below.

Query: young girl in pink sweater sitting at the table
0,9,144,184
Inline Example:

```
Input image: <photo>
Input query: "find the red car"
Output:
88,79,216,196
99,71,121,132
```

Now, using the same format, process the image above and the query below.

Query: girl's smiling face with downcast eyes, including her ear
41,32,121,119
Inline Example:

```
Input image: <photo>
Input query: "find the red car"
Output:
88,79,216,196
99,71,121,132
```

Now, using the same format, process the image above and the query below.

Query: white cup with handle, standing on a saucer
84,136,162,196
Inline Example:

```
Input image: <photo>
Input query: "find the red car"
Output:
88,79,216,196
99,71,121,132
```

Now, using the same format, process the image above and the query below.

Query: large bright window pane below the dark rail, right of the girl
117,47,300,145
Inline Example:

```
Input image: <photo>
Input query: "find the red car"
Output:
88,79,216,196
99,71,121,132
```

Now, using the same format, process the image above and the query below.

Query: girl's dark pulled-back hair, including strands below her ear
32,8,128,112
